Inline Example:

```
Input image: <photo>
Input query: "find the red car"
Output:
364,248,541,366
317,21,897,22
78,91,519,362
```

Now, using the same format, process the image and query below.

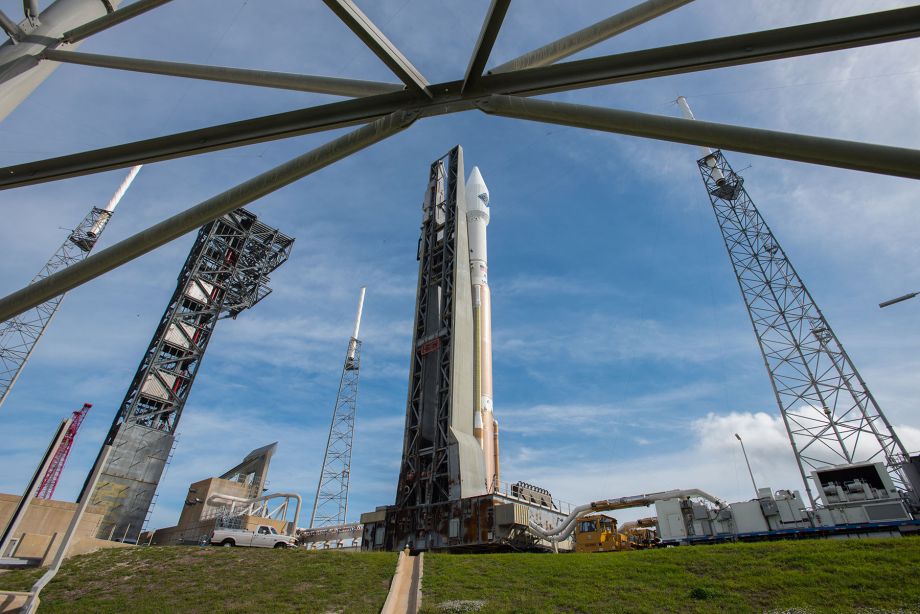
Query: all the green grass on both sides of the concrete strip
0,538,920,614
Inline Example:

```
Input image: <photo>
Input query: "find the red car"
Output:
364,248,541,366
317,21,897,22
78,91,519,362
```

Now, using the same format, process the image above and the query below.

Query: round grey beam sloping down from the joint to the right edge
479,96,920,179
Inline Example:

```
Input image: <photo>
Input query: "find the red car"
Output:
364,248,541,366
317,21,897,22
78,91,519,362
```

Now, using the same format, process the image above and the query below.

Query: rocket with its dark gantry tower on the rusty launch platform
361,146,563,550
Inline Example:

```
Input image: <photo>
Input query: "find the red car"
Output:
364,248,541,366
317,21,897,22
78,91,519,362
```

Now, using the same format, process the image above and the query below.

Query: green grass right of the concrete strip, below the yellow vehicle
423,538,920,614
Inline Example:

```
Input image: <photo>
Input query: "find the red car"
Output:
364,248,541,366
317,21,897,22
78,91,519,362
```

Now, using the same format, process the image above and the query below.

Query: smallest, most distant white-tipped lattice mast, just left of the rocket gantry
310,288,366,529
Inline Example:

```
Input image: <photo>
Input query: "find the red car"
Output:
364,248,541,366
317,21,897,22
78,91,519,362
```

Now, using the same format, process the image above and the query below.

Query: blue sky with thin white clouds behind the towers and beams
0,0,920,527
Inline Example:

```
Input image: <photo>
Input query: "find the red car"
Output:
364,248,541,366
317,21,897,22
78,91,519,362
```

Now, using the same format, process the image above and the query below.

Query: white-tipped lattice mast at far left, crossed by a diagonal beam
0,166,141,406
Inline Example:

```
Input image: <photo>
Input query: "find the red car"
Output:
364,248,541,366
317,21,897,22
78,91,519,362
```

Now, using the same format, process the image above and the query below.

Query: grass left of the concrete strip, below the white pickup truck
0,546,396,614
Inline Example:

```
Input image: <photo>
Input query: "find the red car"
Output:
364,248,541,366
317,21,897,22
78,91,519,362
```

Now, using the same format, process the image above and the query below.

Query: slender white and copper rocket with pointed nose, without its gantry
466,166,499,492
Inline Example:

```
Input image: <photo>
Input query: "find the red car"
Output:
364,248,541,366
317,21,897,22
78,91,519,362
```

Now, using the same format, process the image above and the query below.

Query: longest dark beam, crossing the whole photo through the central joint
0,0,920,189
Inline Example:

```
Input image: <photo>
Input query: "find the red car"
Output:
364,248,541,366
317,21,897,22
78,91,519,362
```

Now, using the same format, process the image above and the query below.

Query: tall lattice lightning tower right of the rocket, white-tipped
677,96,920,505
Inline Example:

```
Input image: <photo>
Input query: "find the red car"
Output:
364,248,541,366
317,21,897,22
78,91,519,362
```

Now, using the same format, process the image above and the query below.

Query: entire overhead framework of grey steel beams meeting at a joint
0,0,920,328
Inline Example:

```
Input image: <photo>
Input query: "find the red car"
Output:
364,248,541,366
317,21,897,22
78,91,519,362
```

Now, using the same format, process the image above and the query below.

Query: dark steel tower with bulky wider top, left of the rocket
84,209,294,542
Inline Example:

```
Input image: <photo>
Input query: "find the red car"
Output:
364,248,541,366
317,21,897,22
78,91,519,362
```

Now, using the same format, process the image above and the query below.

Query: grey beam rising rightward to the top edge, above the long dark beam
489,0,693,74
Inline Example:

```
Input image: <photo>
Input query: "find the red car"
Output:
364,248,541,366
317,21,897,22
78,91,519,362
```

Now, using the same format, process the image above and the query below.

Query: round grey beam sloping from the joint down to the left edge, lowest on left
0,112,415,320
